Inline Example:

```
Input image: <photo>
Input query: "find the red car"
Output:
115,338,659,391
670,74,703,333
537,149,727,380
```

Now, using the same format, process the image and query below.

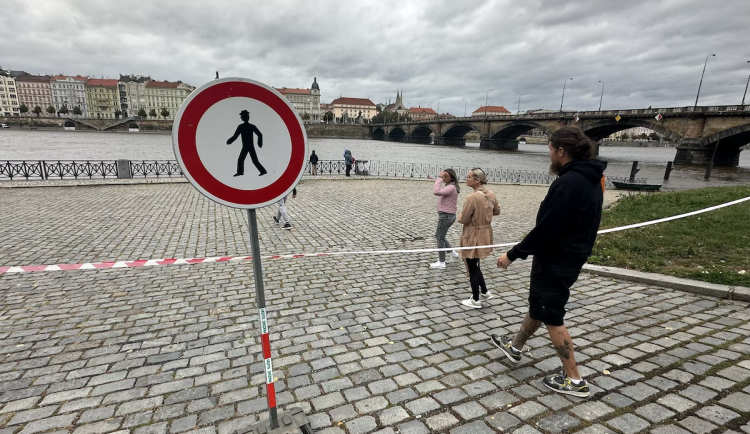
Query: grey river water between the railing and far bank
0,129,750,190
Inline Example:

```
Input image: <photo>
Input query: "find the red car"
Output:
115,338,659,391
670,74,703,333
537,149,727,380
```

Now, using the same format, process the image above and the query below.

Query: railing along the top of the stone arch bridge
369,105,750,126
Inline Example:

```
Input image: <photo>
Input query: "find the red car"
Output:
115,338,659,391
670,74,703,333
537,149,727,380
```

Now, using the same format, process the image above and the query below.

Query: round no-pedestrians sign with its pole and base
172,77,310,433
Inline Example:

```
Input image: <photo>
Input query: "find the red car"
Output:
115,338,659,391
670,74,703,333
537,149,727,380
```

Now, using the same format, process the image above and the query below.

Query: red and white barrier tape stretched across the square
0,196,750,274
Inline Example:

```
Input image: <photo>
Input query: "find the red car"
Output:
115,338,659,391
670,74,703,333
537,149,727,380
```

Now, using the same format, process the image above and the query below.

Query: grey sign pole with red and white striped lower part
247,208,279,429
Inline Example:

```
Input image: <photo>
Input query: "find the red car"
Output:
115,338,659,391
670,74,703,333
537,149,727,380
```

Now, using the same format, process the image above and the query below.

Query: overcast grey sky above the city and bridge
0,0,750,116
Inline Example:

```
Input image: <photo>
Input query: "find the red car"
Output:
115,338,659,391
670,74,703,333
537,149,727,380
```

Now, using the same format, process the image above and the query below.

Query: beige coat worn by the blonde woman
458,186,500,259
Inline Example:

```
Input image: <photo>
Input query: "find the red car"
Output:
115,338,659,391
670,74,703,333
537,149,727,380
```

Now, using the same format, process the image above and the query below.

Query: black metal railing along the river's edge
0,160,646,186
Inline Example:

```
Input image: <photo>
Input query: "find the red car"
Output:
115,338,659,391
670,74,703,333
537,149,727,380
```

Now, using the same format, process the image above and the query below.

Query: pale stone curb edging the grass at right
583,264,750,302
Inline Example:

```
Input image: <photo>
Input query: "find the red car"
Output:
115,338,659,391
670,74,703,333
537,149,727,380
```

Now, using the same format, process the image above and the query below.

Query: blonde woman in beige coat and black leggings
458,168,500,309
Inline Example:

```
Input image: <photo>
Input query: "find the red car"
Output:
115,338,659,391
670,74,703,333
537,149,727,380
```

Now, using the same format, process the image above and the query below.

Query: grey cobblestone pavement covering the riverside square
0,181,750,434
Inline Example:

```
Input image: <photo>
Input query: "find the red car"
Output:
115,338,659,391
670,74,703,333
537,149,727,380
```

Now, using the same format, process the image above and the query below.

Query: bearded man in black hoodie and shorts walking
492,127,607,397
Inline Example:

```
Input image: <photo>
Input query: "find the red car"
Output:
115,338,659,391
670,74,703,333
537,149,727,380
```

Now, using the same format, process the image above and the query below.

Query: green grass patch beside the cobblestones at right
589,186,750,287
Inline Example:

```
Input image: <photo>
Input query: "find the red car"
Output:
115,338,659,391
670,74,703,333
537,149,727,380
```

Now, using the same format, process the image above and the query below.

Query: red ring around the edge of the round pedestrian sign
177,81,306,208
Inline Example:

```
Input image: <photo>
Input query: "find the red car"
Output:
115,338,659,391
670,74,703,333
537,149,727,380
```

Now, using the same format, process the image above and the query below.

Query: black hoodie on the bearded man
508,160,607,265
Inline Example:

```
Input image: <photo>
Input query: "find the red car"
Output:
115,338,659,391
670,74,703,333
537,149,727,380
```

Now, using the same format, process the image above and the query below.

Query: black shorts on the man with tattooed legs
529,256,583,326
